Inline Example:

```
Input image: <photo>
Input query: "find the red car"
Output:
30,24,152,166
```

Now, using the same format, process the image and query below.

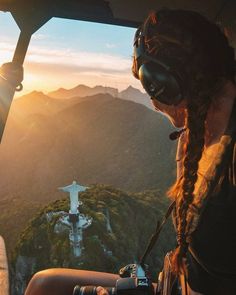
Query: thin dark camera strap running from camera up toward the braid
140,201,175,266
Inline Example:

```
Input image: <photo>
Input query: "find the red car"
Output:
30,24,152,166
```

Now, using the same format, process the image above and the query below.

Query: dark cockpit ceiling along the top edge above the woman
0,0,236,27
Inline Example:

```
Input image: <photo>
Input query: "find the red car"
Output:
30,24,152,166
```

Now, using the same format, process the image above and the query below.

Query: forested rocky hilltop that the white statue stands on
11,185,175,295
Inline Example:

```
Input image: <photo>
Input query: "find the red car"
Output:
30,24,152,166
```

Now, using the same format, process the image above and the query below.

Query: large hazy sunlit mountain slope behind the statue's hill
0,94,175,206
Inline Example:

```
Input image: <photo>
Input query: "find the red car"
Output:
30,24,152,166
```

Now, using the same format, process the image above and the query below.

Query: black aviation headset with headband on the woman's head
134,20,184,105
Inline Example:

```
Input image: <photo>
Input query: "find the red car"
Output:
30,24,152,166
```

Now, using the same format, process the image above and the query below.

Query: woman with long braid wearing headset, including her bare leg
26,10,236,295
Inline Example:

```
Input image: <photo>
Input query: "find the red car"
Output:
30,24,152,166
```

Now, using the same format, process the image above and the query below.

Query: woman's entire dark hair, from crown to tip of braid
136,9,235,273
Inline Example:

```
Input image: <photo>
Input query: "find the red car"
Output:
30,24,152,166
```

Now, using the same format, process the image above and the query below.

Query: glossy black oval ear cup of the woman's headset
139,62,183,105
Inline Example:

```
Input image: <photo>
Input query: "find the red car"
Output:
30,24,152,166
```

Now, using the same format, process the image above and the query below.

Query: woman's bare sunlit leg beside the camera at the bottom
25,268,119,295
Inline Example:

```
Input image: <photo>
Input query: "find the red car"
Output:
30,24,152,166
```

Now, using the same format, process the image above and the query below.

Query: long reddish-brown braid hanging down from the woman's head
173,96,209,273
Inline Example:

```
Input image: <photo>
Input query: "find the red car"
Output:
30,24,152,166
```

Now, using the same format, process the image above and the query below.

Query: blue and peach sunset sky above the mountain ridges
0,12,143,94
